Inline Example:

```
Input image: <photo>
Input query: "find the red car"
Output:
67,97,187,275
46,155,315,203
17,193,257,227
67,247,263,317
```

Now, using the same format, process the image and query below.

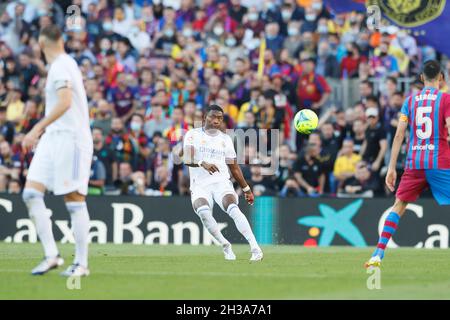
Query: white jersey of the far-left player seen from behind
45,53,92,147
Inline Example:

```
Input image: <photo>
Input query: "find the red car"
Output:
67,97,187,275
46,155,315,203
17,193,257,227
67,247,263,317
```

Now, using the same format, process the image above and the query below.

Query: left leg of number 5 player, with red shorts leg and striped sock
365,170,428,267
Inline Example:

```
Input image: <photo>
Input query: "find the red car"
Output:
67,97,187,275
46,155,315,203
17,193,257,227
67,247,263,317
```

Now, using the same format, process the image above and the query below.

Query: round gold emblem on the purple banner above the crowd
367,0,447,27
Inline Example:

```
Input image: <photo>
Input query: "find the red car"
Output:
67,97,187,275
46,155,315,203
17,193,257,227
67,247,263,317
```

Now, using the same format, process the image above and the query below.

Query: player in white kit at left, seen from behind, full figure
22,25,93,276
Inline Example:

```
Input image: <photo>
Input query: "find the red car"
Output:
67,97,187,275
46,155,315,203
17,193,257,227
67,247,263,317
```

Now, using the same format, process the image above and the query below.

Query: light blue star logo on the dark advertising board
297,199,367,247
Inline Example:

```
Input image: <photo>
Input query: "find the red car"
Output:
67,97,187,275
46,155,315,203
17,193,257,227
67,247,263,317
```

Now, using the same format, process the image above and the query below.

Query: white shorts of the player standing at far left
27,131,93,195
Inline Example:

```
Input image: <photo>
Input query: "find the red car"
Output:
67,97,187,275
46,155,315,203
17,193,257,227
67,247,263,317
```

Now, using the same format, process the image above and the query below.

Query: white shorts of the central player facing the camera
191,180,239,212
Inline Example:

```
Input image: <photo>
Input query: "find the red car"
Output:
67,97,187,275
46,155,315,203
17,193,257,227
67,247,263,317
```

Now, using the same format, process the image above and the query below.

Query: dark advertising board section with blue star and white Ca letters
288,199,450,249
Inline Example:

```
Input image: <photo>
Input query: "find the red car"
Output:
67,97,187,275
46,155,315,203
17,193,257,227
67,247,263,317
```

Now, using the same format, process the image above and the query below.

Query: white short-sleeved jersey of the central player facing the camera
183,128,236,189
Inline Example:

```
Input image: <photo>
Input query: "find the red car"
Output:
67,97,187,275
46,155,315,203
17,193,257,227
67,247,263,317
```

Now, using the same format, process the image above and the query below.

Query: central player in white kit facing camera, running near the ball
183,105,263,261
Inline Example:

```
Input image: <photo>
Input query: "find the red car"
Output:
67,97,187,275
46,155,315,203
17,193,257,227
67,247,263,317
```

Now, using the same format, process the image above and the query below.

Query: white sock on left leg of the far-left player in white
22,188,58,258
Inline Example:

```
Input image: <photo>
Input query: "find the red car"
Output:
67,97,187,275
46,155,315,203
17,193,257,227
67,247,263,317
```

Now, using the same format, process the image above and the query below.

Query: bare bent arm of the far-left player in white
22,87,72,151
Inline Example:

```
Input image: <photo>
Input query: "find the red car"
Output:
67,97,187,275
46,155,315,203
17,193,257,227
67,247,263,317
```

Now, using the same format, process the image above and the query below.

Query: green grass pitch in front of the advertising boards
0,243,450,299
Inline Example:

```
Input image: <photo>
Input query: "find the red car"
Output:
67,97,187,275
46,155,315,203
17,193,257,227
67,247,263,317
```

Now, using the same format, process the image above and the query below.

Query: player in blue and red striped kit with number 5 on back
365,60,450,267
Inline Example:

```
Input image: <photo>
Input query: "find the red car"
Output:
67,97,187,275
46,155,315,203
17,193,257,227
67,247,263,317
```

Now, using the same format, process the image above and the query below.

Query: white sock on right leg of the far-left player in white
66,202,89,268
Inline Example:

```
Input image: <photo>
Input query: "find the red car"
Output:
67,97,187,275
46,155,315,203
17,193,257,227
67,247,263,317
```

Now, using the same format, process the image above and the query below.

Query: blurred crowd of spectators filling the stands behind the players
0,0,450,197
